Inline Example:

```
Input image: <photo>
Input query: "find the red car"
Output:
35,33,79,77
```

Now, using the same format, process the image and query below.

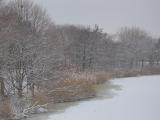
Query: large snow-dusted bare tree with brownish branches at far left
0,1,52,97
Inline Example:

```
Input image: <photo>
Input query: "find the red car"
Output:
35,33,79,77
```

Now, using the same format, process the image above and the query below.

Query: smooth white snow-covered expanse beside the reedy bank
27,76,160,120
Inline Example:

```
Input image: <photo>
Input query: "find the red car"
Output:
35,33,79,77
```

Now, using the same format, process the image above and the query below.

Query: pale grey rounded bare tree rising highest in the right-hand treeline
118,27,153,68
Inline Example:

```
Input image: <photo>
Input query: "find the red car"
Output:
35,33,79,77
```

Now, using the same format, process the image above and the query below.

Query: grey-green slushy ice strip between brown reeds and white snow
24,81,121,120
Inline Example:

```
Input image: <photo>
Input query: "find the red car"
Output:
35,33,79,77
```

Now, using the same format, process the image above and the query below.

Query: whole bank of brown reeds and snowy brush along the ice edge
0,68,159,120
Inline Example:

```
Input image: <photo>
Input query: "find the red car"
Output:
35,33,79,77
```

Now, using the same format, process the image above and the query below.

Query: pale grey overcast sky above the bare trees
36,0,160,37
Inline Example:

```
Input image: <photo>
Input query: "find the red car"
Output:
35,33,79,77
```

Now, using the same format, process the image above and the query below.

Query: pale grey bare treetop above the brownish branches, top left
8,0,50,33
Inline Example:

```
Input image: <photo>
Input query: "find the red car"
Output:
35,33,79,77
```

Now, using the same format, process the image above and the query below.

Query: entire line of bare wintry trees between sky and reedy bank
0,0,160,97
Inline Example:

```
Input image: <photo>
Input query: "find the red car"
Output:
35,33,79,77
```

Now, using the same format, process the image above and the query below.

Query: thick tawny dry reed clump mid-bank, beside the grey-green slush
47,72,111,102
